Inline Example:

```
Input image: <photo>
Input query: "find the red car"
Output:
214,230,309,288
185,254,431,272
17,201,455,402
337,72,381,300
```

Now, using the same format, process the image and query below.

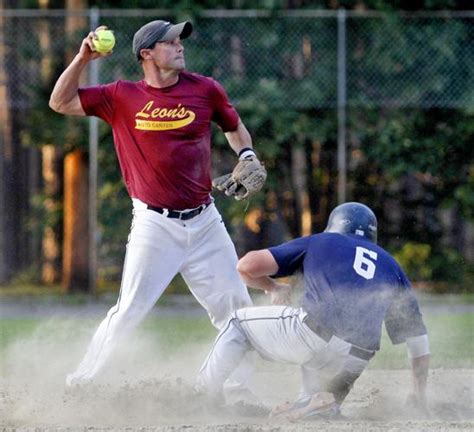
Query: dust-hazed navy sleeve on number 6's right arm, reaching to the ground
385,270,427,344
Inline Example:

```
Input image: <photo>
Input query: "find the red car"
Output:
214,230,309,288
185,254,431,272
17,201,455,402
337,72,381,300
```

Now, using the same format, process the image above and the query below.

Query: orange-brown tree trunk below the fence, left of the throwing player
62,150,89,292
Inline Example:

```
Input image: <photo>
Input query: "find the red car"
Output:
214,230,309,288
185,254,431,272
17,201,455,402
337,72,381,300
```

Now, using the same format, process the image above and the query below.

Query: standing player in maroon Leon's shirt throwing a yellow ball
50,20,265,385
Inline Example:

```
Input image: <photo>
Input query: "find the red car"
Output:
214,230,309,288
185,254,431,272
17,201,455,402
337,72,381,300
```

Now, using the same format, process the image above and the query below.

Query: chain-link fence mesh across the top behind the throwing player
0,10,474,109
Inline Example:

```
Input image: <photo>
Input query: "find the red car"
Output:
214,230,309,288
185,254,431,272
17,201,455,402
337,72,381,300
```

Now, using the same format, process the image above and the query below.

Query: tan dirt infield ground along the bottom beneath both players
0,364,474,432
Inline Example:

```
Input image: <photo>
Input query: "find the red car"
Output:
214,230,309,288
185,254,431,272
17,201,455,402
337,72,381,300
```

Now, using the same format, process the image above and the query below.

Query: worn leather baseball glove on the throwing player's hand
212,157,267,200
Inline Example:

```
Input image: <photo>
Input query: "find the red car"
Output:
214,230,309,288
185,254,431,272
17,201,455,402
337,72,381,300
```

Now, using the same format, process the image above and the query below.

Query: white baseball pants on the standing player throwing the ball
66,199,252,385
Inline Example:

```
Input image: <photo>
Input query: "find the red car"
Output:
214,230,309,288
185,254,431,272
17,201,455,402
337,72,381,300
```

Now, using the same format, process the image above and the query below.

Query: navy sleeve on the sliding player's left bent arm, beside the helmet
268,237,310,277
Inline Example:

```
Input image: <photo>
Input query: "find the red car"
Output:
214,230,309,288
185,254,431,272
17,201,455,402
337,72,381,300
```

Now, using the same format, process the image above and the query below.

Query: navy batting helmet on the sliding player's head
324,202,377,243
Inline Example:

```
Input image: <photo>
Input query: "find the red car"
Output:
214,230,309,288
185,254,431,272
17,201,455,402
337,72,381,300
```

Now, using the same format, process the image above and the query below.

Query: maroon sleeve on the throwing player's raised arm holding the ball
79,82,118,124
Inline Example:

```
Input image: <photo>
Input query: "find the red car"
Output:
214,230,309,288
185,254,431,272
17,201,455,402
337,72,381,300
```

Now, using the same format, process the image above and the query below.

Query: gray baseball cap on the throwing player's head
132,20,193,60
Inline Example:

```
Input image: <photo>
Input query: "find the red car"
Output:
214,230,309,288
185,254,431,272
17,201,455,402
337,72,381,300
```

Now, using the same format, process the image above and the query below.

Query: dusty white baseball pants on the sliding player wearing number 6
197,306,369,403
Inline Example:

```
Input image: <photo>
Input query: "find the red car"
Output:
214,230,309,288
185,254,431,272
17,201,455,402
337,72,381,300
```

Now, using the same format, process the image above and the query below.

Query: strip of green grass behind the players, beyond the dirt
0,313,474,369
